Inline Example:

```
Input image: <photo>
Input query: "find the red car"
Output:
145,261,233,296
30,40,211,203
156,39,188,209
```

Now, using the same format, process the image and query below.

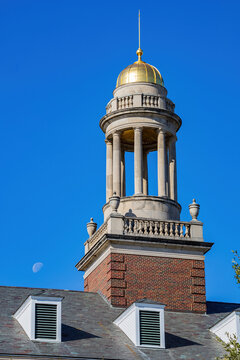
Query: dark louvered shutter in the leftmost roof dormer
35,304,57,340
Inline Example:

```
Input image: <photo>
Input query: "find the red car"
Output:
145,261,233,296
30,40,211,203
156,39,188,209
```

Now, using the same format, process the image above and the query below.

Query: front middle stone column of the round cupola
134,128,143,195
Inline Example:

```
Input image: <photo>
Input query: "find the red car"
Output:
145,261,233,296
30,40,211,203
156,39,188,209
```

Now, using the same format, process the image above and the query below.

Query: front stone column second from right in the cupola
157,129,167,196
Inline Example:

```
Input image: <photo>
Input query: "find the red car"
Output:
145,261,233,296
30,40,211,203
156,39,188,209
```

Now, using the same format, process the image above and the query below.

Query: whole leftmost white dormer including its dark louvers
13,296,62,342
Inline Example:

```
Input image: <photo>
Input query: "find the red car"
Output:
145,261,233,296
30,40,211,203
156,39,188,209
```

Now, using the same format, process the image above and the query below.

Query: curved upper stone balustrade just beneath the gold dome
106,94,175,114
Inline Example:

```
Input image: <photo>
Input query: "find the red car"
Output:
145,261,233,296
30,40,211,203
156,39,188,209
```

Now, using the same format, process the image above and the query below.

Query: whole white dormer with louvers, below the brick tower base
114,299,165,348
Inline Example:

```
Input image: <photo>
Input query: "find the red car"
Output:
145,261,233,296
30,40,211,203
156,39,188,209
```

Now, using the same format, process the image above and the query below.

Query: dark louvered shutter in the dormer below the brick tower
139,310,160,346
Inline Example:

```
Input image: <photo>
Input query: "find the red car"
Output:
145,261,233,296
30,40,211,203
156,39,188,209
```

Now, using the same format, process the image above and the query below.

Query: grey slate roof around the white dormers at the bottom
0,287,239,360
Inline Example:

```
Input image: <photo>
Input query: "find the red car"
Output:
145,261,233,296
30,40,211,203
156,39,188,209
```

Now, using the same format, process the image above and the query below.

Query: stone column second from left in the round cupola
113,132,121,196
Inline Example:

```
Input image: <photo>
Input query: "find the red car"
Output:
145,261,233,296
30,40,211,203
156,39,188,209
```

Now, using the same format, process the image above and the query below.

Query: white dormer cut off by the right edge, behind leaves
210,311,240,343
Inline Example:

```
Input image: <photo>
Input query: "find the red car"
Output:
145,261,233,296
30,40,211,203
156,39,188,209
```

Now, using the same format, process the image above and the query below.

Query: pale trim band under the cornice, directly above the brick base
83,244,205,279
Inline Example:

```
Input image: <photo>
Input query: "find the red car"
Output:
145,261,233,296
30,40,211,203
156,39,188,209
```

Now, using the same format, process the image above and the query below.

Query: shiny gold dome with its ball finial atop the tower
116,48,164,87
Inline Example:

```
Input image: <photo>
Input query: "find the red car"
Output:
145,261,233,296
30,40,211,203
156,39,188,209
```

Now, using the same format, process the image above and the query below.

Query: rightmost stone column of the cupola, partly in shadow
169,137,177,201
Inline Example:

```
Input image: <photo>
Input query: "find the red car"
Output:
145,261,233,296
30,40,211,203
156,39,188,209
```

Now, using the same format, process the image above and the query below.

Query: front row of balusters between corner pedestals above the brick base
124,217,191,238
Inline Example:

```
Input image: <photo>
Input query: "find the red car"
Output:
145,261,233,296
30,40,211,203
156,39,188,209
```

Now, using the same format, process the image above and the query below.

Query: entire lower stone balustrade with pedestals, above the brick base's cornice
84,213,203,253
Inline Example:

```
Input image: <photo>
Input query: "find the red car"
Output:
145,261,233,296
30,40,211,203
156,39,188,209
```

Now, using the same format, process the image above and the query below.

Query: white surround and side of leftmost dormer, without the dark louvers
13,295,62,342
